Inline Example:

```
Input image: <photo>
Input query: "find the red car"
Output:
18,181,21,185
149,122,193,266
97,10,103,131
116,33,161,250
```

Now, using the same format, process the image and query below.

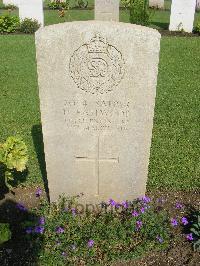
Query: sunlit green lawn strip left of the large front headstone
0,35,41,187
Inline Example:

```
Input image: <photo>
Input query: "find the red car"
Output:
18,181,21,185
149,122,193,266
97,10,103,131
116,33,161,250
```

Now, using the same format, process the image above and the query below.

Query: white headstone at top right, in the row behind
169,0,196,32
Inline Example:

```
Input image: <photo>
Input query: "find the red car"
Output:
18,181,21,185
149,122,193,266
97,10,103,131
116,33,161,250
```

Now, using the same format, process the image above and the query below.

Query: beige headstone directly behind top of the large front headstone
95,0,119,21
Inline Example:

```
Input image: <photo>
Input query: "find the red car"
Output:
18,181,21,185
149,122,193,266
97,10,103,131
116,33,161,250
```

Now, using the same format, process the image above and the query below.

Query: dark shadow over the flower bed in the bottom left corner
0,199,42,266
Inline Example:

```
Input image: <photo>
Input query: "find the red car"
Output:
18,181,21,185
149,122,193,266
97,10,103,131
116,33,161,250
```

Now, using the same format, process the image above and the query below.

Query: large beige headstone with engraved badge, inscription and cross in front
36,21,160,203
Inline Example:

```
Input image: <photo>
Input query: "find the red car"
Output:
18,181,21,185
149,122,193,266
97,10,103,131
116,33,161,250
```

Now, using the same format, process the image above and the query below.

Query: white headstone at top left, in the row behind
19,0,44,26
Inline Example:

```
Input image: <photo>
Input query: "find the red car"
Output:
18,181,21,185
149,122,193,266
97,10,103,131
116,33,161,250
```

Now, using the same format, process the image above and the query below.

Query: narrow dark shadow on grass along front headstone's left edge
31,125,50,201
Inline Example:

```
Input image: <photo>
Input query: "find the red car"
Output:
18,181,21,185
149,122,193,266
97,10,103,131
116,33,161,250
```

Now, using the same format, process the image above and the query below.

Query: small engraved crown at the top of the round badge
87,34,108,53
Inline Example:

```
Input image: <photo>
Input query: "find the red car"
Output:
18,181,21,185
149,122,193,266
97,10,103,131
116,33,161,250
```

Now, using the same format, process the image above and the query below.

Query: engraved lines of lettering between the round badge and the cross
63,100,131,131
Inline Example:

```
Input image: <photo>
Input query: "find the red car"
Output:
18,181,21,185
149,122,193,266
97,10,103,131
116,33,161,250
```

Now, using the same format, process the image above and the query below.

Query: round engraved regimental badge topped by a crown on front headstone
69,34,125,94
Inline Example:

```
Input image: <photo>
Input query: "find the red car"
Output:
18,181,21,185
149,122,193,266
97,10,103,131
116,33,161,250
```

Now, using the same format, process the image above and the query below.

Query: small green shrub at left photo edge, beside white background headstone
0,15,20,33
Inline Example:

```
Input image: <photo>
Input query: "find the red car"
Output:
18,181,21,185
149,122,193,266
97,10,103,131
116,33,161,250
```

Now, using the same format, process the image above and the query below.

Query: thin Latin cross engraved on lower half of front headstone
75,137,119,195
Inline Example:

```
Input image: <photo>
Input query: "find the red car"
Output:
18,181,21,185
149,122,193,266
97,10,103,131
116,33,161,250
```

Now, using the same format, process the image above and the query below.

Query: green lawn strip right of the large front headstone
149,37,200,190
